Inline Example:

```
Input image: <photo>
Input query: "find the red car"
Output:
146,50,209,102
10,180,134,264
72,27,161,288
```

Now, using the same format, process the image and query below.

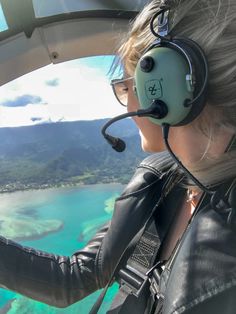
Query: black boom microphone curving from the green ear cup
101,100,168,153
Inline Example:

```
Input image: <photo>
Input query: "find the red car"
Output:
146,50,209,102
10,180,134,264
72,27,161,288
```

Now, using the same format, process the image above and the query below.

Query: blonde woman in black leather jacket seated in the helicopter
0,0,236,314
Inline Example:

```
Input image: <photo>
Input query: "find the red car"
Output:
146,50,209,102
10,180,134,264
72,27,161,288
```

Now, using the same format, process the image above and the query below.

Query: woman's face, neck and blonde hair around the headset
114,0,236,258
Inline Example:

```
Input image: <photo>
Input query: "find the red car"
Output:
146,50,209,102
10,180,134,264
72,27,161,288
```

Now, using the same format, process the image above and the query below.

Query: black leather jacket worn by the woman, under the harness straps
0,154,236,314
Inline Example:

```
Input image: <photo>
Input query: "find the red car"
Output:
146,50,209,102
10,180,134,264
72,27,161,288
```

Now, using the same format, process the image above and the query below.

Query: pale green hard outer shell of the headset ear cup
134,46,193,125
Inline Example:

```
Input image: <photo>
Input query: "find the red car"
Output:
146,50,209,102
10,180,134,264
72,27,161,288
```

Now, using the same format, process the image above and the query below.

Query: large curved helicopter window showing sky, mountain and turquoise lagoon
0,56,144,314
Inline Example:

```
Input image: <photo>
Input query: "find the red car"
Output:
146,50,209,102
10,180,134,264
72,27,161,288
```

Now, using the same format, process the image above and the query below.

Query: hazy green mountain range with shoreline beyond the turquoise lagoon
0,119,148,192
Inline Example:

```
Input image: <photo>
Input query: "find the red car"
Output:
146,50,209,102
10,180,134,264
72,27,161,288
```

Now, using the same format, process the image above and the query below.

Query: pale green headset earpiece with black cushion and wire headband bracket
134,6,208,126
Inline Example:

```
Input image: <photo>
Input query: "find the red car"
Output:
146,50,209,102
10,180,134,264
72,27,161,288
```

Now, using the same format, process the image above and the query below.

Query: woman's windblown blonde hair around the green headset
119,0,236,185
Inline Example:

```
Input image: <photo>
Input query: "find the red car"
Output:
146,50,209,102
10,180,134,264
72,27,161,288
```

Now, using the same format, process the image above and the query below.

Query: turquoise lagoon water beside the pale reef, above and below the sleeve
0,184,123,314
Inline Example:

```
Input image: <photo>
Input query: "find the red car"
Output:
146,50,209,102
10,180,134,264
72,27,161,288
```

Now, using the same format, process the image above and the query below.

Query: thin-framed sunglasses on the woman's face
111,77,133,107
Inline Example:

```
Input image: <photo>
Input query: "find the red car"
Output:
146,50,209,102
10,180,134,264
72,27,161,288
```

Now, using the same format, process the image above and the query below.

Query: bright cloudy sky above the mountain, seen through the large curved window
0,56,125,127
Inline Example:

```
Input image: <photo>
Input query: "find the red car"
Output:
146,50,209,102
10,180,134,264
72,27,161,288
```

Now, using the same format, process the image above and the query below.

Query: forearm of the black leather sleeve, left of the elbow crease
0,224,108,307
